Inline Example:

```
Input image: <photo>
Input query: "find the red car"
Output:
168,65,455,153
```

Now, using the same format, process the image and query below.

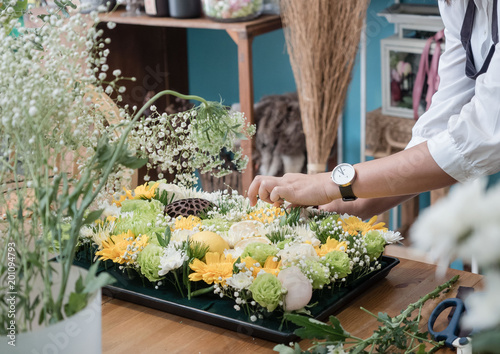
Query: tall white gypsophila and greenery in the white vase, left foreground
0,1,254,353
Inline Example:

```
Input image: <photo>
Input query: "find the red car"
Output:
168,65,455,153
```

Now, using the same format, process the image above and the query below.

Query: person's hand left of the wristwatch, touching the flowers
248,172,340,206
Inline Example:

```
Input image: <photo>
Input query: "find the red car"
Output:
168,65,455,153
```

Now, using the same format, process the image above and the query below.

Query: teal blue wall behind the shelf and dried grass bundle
188,0,436,163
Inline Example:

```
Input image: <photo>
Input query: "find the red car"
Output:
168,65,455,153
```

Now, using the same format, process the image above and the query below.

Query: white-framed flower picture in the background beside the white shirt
380,36,444,118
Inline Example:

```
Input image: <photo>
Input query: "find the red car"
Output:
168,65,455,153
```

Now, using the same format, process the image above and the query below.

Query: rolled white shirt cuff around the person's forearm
427,131,477,183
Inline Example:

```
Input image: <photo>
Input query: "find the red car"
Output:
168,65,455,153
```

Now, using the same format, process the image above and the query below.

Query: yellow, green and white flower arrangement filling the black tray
80,181,401,321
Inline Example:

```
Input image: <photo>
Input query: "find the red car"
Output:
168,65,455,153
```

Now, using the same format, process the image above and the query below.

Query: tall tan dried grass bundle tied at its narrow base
281,0,369,173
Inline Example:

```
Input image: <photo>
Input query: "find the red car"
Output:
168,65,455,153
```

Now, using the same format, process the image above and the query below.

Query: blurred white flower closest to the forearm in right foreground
410,179,487,269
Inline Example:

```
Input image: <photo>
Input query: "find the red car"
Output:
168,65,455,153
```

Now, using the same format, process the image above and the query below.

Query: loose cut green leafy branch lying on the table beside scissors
274,275,459,354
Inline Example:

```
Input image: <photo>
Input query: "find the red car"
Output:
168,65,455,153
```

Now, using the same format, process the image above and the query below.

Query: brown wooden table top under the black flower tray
102,254,482,354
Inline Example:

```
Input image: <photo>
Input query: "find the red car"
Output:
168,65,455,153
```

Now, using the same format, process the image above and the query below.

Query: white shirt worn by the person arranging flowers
408,0,500,182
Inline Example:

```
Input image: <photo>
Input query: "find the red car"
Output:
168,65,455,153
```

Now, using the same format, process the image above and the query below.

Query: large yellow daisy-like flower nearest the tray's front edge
189,252,234,285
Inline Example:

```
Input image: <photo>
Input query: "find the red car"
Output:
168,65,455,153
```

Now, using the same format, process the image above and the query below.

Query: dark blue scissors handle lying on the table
427,298,472,354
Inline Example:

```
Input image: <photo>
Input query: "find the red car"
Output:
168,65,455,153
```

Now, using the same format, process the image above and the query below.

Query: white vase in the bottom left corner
0,267,102,354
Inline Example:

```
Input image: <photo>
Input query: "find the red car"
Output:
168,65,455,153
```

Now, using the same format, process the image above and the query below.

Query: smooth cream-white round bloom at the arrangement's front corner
278,266,312,311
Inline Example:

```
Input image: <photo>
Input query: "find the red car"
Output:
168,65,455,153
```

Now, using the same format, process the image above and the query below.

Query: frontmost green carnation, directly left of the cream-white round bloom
248,273,283,312
